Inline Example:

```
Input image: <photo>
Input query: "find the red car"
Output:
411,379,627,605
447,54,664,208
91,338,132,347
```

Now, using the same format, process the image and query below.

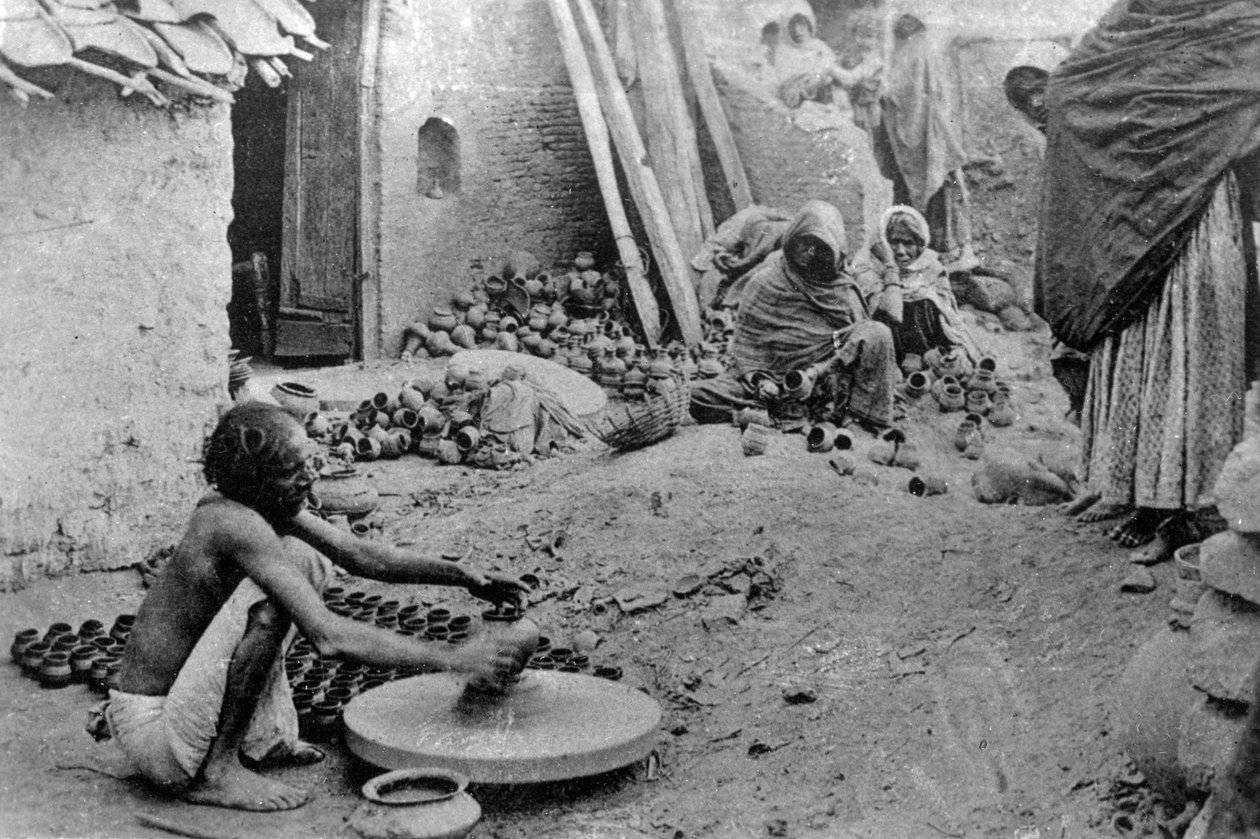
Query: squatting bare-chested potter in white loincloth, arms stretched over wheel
105,402,525,810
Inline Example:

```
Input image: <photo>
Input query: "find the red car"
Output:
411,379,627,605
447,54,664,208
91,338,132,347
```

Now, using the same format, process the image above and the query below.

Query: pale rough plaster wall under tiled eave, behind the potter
0,73,232,590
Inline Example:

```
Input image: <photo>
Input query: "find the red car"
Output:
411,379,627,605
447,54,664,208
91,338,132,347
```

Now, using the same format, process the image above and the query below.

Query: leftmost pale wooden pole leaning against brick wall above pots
549,0,660,346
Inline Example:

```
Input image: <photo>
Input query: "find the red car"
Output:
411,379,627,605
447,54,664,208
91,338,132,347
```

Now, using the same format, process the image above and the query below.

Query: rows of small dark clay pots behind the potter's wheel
285,586,621,742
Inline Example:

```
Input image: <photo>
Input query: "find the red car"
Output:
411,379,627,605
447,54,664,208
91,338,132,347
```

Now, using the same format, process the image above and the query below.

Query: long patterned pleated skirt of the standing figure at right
1081,175,1255,510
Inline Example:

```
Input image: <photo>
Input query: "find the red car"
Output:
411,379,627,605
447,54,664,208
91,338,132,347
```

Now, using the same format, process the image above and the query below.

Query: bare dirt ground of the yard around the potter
0,309,1171,839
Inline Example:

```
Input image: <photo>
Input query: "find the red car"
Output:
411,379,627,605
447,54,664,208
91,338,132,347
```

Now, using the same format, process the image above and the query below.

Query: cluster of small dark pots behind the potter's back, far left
9,615,136,695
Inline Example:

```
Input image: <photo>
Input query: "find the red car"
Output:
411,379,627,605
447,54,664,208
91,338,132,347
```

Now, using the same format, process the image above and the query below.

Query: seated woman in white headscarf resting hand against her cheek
871,204,980,364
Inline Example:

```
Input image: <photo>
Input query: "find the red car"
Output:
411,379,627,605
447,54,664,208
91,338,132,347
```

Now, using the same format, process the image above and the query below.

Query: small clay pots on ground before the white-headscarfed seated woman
901,348,1018,428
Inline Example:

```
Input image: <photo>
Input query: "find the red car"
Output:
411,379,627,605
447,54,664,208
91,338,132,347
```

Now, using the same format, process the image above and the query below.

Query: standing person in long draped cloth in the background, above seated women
872,14,977,271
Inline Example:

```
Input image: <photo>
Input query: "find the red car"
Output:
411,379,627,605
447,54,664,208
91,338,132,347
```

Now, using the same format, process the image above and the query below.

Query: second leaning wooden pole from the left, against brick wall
573,0,702,345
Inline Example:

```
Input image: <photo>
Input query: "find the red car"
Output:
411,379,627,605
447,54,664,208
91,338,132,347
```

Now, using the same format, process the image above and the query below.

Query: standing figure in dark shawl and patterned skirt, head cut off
1033,0,1260,564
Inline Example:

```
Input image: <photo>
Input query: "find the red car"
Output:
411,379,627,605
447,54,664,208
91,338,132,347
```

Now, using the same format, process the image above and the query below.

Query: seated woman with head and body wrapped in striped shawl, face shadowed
690,202,897,428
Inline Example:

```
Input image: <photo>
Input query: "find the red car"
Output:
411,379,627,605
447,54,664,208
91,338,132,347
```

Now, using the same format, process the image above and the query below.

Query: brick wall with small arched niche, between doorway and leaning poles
378,0,611,355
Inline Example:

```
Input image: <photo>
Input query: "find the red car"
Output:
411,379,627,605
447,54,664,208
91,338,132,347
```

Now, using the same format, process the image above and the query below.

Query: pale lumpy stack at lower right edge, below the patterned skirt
1116,388,1260,802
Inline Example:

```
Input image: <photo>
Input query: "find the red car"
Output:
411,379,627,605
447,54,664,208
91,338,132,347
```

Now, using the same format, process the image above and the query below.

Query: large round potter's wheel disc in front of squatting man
344,670,660,784
